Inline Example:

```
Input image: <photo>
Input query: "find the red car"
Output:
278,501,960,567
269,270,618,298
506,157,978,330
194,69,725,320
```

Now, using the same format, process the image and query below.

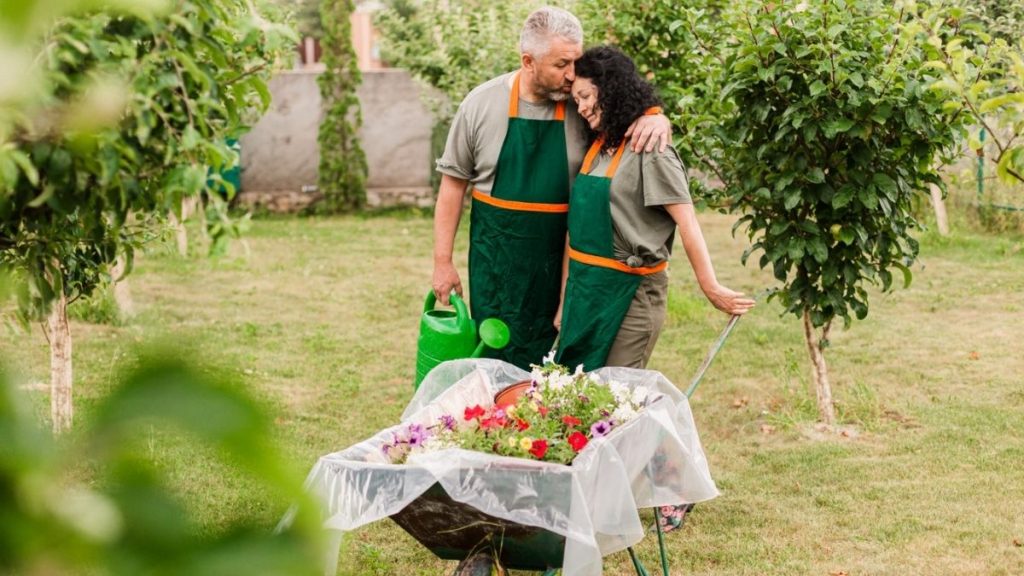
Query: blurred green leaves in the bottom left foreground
0,356,322,576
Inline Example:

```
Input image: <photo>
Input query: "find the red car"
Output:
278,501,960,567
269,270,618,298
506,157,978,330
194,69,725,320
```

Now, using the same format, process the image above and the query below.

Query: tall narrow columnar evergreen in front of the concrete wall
316,0,368,213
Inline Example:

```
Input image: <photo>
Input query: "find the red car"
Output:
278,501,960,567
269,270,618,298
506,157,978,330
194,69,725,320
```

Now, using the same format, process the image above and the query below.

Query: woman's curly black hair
575,46,662,150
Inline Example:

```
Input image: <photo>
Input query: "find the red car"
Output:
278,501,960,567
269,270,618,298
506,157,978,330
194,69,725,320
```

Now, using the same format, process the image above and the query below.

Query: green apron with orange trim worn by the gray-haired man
469,75,569,370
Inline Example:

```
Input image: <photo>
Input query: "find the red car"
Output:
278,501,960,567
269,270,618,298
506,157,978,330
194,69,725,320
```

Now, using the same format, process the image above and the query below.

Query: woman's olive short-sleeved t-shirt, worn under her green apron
589,146,693,266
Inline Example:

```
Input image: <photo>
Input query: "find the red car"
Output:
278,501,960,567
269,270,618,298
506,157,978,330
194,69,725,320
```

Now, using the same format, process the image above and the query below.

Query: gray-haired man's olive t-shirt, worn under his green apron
437,73,587,194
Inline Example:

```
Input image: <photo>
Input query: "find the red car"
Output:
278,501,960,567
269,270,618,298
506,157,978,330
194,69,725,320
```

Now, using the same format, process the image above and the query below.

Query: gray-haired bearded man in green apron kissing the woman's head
433,6,670,370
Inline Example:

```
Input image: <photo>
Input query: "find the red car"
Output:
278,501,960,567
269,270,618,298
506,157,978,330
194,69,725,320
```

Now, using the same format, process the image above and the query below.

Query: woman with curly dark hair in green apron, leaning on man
555,46,754,370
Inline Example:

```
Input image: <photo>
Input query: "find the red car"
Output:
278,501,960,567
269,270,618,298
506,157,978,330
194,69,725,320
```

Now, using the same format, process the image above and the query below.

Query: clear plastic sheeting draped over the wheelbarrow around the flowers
306,360,718,576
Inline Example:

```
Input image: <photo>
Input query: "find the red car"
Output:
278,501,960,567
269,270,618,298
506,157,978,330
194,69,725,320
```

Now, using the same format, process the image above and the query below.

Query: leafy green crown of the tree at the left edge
0,0,294,320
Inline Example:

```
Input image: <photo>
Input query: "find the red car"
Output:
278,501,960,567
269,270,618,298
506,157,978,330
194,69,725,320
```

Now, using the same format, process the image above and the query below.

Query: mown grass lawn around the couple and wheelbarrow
0,207,1024,576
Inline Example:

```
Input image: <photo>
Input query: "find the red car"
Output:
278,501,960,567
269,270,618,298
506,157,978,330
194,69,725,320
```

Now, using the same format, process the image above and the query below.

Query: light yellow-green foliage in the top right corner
921,5,1024,184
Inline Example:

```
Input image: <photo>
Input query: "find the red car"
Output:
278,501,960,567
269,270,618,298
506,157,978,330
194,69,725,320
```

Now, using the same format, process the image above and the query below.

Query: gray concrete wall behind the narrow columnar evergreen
240,69,433,211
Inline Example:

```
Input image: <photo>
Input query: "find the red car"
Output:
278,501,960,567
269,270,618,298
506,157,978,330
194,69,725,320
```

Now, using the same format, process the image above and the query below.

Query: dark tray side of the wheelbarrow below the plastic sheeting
391,484,565,571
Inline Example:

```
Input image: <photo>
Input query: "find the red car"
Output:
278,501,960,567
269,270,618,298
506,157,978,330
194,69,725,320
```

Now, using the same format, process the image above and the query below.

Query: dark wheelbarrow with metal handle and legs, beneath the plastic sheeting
390,316,739,576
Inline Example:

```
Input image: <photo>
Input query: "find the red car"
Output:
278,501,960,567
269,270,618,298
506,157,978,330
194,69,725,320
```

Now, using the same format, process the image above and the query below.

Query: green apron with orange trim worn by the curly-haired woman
555,139,667,371
